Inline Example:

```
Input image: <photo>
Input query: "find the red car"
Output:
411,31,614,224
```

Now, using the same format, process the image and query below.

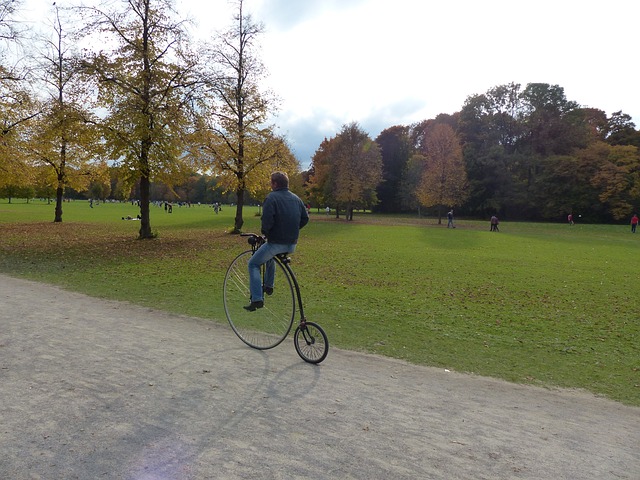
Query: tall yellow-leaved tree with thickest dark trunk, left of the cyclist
83,0,199,239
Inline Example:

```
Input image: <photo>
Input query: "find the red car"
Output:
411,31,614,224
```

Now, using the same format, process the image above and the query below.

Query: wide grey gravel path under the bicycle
0,275,640,480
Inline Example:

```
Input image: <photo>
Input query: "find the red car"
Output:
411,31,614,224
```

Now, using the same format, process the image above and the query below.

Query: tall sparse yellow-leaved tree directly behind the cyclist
194,0,290,233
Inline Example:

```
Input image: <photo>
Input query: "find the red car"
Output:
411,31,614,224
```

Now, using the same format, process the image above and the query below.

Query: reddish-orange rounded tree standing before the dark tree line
416,124,467,224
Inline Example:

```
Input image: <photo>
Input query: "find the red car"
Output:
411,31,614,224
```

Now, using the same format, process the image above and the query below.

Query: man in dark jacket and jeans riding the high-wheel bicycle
244,172,309,312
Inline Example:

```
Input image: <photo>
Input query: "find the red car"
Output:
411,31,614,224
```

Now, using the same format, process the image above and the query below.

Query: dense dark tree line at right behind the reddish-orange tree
376,83,640,221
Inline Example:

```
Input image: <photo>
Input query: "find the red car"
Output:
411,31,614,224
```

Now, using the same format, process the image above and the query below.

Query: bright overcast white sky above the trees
20,0,640,168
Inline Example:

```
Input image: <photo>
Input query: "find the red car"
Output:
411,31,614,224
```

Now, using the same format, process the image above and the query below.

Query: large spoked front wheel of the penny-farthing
223,250,295,350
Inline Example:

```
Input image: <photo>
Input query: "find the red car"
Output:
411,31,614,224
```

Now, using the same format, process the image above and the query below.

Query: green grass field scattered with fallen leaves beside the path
0,200,640,405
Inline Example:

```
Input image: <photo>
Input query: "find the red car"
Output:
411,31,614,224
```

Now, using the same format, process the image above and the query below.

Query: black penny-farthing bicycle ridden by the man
223,233,329,363
